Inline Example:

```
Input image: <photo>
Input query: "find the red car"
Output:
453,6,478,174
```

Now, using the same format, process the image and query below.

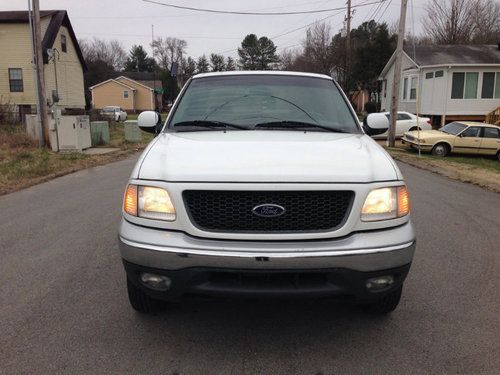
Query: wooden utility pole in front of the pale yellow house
33,0,50,147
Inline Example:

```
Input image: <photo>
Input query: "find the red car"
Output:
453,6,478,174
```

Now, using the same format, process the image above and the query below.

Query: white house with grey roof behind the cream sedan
379,44,500,125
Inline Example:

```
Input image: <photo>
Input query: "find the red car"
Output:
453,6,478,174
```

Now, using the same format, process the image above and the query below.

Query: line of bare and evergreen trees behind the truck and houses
79,0,500,109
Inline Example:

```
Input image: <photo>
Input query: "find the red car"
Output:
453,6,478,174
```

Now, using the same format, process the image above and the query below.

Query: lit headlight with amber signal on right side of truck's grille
361,186,410,221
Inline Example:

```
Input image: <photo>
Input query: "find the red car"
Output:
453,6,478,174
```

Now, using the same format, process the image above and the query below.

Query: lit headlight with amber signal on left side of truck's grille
123,185,176,221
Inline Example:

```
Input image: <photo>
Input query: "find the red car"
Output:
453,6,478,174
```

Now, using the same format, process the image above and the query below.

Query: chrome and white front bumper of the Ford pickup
119,219,415,272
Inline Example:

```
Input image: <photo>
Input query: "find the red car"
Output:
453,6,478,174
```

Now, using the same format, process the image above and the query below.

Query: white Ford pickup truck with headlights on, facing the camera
119,71,415,313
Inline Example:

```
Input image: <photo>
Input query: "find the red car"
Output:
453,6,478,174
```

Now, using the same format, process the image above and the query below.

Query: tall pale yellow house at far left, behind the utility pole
0,10,86,118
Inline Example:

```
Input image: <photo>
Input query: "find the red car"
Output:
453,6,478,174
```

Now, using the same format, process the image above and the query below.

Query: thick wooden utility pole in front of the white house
388,0,408,147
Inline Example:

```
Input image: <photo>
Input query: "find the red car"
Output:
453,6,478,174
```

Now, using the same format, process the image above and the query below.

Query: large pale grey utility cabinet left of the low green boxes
55,116,92,152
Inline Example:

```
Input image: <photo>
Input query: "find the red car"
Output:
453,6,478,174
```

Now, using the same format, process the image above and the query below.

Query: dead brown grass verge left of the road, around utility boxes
0,123,153,195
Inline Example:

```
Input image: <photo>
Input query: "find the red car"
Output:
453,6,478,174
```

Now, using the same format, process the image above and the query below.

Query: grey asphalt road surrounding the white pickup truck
0,159,500,375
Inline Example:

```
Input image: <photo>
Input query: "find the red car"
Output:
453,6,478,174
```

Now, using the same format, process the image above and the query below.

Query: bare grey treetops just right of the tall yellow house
78,37,127,71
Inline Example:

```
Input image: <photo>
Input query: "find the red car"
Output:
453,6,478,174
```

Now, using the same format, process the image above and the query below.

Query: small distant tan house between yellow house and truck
89,76,161,112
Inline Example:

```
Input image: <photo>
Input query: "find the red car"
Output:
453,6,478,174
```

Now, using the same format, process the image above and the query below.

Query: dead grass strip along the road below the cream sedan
387,148,500,193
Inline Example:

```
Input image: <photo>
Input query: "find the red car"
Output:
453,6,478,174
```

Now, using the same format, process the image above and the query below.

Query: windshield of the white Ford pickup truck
169,75,360,133
